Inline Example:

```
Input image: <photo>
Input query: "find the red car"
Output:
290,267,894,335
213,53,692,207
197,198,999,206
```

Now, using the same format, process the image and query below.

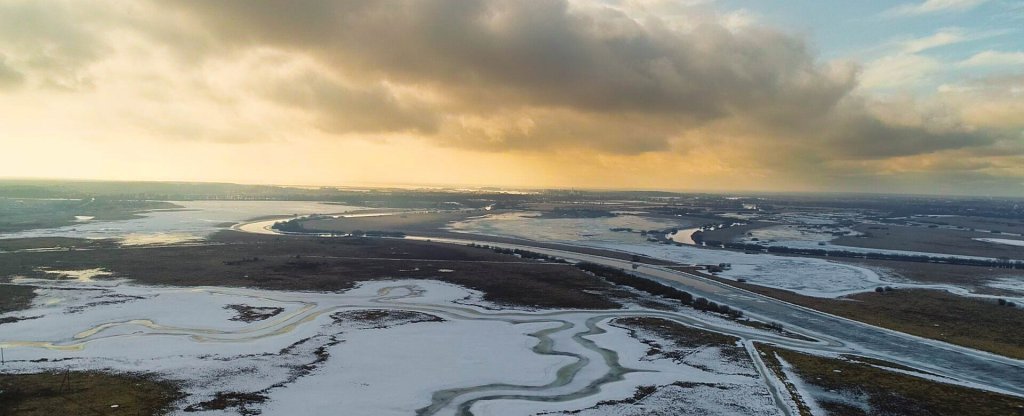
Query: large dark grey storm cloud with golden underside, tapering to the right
159,0,991,159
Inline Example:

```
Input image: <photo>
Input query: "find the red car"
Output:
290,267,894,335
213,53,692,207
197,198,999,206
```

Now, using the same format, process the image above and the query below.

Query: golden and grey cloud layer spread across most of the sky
0,0,1024,193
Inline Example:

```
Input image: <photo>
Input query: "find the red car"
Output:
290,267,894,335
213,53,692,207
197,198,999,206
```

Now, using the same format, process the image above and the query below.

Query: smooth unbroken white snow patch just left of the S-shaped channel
264,321,571,416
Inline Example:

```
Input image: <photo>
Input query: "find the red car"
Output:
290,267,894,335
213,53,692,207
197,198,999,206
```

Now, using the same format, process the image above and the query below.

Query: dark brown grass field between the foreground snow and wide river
0,233,621,309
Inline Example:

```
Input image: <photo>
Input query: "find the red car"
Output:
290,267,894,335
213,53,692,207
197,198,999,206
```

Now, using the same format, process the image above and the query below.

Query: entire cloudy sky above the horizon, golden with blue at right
0,0,1024,197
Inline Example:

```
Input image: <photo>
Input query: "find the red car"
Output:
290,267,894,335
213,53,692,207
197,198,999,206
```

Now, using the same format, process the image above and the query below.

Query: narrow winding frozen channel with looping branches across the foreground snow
0,276,835,416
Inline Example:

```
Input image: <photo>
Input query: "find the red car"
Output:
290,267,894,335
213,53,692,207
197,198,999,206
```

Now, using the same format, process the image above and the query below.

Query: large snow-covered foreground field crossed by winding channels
0,271,797,415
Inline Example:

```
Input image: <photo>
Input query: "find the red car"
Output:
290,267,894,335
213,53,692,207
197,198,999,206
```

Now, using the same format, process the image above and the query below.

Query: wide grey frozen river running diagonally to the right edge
407,235,1024,397
